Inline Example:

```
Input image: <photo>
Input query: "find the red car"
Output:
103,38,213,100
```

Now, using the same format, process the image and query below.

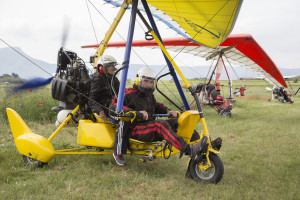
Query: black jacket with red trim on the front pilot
111,84,169,120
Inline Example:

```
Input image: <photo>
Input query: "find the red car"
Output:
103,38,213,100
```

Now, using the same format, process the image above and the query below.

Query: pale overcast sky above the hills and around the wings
0,0,300,74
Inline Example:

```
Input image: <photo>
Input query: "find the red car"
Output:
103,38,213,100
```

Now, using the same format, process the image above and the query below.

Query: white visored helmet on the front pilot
135,67,156,93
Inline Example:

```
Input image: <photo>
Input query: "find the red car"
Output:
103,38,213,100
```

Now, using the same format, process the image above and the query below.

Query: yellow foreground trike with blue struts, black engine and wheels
7,0,245,183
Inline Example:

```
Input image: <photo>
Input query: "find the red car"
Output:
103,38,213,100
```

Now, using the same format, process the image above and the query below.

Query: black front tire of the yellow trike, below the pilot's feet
189,153,224,184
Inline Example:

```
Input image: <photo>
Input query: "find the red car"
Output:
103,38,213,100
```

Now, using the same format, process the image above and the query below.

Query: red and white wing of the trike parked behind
84,34,287,87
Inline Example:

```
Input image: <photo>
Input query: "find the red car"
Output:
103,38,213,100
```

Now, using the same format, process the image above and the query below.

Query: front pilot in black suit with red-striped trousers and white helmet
111,67,220,165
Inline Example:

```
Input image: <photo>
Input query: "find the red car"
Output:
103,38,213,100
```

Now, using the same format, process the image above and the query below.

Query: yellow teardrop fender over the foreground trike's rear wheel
6,108,54,163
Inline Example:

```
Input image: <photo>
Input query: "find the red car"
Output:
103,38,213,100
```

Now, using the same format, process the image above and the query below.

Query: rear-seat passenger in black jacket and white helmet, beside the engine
88,55,120,120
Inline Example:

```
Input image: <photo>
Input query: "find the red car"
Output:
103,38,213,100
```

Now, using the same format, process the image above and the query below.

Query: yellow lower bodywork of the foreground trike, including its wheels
7,106,224,183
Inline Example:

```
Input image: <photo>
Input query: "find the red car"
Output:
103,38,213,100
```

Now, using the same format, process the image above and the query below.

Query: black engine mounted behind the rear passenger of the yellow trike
51,48,91,125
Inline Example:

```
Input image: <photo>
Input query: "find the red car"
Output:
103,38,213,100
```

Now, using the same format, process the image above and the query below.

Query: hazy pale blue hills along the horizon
0,47,300,80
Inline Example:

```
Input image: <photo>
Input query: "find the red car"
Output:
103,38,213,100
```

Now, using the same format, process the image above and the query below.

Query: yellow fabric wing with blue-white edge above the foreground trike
104,0,243,48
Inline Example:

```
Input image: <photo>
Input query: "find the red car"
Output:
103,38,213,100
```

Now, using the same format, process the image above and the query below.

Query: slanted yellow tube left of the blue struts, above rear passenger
94,0,128,72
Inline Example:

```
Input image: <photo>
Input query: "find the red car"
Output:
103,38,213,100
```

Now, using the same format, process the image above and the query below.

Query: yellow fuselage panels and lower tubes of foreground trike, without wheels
7,106,214,163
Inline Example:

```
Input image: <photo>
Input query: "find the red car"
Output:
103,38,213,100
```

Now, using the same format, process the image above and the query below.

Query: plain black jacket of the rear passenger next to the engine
88,72,120,115
